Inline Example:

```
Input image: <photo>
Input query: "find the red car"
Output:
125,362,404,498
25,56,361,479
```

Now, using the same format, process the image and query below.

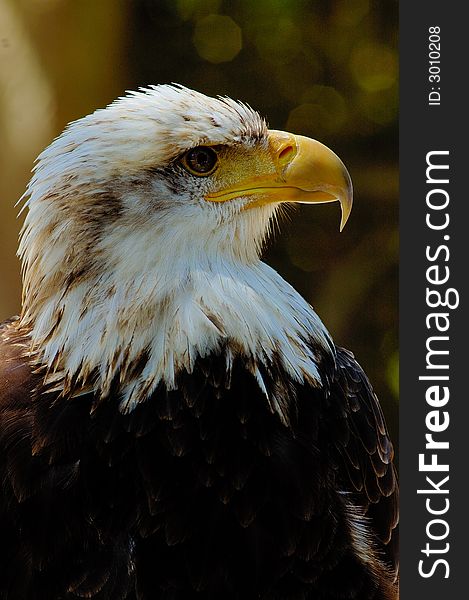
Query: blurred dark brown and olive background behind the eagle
0,0,398,440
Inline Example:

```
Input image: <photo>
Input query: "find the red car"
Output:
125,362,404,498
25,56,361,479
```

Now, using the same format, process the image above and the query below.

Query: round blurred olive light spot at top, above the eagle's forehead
193,15,243,64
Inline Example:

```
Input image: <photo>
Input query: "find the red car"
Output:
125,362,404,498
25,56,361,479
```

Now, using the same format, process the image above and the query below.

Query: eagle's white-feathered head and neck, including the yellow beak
20,85,352,408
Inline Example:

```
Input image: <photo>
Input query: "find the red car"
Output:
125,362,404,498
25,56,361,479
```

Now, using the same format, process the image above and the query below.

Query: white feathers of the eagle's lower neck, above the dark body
26,244,332,411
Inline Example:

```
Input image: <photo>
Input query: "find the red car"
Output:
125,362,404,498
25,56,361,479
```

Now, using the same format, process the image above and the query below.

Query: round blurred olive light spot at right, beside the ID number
350,43,398,92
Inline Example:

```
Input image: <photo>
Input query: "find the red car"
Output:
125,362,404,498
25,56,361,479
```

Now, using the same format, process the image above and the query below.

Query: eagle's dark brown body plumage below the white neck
0,324,397,600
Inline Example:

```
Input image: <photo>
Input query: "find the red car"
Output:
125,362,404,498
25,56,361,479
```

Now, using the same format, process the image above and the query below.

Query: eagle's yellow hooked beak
205,130,353,231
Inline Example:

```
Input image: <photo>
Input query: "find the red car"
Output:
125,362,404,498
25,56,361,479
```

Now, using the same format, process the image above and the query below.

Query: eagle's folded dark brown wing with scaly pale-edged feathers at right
326,348,399,579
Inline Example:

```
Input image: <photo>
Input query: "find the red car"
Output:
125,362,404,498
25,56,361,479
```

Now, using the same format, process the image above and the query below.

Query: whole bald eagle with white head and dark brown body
0,85,397,600
